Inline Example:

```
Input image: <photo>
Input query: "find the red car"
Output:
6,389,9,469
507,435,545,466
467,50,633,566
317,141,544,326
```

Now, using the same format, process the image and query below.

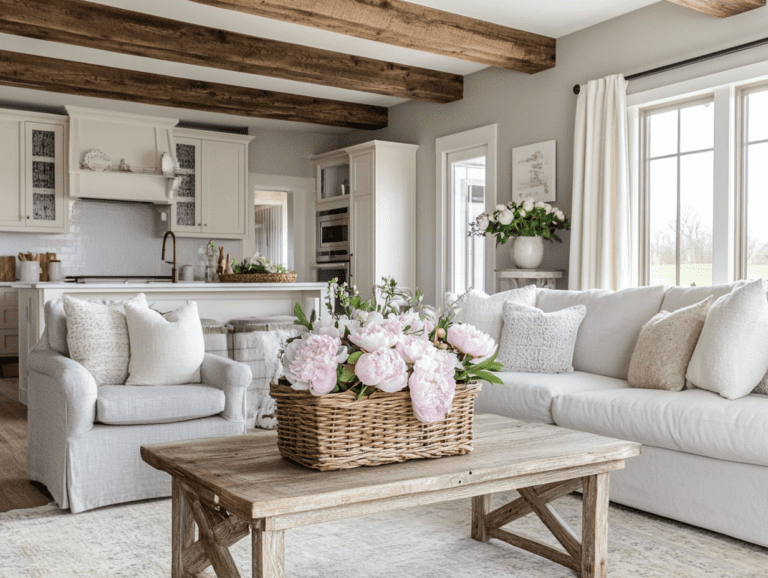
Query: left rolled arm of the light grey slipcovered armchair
27,349,97,437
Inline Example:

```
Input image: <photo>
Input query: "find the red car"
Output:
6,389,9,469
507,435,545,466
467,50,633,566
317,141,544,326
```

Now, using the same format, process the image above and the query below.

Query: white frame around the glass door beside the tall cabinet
435,124,498,309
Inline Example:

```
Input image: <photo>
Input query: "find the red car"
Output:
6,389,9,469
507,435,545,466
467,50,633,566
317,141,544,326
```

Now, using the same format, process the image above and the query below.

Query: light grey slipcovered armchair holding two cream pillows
27,300,251,513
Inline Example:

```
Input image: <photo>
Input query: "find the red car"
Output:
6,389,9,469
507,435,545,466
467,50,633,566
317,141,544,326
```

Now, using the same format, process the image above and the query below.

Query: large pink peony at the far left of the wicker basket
283,334,348,395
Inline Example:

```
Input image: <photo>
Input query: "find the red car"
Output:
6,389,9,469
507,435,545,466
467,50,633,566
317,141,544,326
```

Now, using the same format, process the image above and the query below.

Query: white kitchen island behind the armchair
13,281,328,404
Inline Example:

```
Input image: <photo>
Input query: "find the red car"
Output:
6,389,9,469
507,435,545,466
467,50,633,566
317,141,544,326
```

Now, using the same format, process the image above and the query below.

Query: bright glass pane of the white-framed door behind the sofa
451,156,485,294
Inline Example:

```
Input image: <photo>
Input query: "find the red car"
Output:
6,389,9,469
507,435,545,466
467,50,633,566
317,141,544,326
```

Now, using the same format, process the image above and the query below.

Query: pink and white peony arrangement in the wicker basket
282,278,502,423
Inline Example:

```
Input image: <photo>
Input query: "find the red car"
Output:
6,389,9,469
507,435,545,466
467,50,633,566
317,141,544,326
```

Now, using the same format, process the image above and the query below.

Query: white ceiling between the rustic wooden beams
0,0,658,134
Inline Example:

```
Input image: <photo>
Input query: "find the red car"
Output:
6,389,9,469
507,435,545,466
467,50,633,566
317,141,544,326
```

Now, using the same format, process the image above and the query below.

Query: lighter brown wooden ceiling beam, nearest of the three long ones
189,0,555,73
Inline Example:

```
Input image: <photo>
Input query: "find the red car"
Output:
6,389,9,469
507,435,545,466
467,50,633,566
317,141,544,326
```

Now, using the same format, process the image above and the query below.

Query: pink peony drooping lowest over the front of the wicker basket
408,351,456,423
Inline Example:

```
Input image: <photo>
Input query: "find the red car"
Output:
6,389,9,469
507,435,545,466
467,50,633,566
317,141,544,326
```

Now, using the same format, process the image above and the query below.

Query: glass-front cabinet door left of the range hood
24,122,64,229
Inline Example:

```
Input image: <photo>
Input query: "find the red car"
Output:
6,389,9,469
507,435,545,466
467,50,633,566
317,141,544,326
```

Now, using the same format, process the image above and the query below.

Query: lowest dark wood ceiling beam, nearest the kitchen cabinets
0,50,387,130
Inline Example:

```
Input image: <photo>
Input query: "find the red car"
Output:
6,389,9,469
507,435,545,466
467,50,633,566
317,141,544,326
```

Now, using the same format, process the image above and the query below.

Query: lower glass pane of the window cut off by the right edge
746,143,768,279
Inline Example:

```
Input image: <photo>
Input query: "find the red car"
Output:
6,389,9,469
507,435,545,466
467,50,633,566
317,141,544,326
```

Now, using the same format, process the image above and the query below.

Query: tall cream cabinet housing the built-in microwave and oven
313,141,418,299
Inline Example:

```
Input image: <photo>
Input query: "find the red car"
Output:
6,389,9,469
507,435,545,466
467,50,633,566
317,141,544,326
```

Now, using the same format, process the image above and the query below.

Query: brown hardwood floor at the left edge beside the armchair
0,377,53,512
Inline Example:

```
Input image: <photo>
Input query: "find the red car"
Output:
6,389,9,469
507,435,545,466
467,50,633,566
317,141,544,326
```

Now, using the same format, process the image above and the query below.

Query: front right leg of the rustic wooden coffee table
581,473,610,578
